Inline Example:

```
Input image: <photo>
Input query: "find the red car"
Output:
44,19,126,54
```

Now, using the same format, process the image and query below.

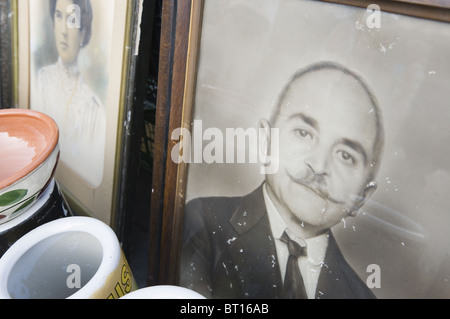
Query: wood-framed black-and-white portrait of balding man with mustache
151,0,450,299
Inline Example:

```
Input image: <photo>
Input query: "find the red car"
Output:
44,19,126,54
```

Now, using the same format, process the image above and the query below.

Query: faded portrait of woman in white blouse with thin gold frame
18,0,137,224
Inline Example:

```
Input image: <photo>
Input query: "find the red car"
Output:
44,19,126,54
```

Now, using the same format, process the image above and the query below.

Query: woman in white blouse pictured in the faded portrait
33,0,106,187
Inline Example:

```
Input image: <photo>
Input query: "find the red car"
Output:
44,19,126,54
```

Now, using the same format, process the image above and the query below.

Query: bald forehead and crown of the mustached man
279,70,377,146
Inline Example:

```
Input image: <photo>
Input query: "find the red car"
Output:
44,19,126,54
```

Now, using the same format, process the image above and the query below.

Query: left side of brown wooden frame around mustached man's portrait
148,0,203,285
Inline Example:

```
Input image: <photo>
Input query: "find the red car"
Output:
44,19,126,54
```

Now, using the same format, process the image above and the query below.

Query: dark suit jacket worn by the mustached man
180,187,375,299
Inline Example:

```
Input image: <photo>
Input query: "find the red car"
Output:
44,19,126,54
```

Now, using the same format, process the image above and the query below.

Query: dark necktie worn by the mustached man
281,232,308,299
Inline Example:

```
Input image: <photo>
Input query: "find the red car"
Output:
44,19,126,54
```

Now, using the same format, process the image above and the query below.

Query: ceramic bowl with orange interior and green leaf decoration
0,109,59,224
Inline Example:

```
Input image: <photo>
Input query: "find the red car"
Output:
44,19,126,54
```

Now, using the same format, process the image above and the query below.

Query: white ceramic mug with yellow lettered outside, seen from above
0,216,137,299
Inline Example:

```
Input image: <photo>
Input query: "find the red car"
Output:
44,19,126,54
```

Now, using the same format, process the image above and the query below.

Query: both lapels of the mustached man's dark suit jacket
227,186,372,299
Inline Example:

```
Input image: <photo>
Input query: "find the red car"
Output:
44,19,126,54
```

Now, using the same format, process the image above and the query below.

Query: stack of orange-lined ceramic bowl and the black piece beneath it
0,109,71,256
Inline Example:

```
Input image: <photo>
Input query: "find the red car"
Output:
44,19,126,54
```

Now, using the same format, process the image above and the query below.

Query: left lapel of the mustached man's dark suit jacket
230,187,282,299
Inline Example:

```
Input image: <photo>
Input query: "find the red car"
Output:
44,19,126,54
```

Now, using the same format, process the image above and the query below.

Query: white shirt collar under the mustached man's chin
263,184,329,265
